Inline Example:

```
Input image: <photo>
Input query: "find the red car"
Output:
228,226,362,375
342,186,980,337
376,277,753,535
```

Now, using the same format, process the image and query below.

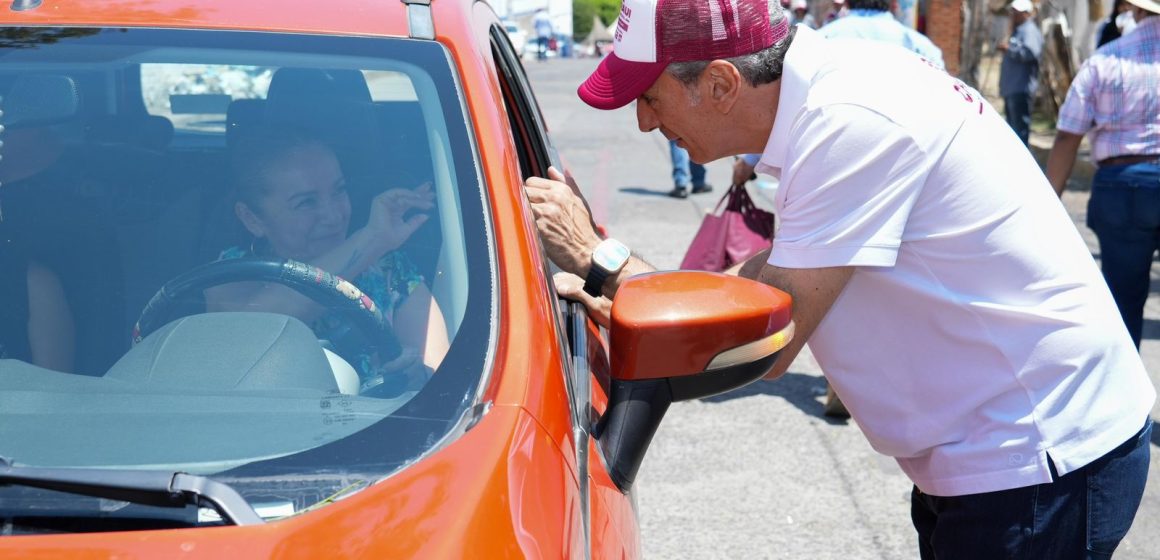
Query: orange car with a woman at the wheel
0,0,792,558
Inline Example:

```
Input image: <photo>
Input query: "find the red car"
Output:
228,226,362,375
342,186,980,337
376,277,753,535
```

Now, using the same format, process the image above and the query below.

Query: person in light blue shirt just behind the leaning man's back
820,0,945,68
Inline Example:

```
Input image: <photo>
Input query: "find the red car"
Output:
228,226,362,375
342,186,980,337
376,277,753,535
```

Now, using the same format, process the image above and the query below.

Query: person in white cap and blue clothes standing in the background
995,0,1043,146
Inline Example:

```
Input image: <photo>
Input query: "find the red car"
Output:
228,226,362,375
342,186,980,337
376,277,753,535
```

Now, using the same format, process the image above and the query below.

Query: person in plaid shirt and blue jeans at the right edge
1047,0,1160,348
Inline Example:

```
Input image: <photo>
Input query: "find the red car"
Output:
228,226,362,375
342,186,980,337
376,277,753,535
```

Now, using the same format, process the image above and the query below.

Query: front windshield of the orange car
0,28,494,531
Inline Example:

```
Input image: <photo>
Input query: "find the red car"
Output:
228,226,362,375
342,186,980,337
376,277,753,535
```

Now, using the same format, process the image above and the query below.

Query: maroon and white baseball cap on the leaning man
577,0,789,109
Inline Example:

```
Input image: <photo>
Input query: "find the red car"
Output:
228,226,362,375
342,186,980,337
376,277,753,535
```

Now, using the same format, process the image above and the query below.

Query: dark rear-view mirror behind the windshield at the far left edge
0,74,80,128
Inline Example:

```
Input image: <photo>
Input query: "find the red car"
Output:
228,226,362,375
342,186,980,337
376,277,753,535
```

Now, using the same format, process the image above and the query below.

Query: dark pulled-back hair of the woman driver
230,124,331,212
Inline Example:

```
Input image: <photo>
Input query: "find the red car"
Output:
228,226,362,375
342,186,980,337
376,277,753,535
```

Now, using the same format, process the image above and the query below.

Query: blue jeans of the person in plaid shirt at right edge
1087,163,1160,348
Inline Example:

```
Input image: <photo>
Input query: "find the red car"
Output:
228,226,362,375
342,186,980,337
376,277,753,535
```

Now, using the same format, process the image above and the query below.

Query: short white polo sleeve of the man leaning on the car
769,106,930,268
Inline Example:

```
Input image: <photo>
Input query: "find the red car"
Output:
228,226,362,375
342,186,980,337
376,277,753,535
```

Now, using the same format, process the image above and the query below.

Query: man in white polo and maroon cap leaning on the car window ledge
524,0,1155,559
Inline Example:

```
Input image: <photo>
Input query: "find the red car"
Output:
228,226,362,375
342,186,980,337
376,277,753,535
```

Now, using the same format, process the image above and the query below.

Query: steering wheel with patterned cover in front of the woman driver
133,257,401,374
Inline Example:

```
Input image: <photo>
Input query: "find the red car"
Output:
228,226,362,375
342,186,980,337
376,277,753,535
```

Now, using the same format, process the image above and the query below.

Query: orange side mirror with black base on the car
596,270,793,492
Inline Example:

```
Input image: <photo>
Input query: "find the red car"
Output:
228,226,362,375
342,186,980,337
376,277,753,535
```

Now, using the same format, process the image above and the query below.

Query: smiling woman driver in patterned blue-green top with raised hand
206,126,449,383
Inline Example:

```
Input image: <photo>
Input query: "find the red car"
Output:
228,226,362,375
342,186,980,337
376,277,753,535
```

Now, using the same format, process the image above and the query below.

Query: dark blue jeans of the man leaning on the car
911,419,1152,560
